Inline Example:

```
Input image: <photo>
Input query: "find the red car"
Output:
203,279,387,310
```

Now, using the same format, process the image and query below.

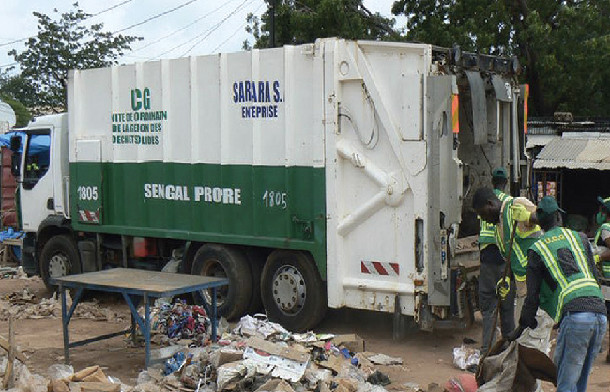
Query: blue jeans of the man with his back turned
553,312,608,392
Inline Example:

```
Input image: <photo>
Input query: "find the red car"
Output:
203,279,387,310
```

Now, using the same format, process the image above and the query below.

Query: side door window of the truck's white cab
23,130,51,189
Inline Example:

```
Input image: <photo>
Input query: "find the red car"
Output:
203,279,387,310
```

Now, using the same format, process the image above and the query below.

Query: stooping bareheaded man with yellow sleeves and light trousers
473,188,553,362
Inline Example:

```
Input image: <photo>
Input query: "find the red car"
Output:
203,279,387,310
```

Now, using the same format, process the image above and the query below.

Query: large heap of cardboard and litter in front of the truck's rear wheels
133,314,410,392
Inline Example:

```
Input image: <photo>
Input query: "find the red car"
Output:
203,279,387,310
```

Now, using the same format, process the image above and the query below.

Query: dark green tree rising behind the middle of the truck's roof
244,0,400,49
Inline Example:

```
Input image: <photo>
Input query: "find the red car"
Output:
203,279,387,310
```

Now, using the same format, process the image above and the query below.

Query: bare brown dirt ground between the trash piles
0,279,610,392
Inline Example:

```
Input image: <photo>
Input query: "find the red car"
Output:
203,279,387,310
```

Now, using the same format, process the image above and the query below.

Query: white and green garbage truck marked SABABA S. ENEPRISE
12,38,527,331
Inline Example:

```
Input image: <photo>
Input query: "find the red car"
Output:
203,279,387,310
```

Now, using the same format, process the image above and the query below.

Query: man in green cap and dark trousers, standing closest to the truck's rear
479,167,515,353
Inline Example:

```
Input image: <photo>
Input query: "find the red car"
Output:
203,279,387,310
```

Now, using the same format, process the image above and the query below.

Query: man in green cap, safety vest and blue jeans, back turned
509,196,607,392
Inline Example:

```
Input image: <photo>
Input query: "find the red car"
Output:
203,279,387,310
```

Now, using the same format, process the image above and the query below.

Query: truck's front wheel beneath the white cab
40,234,81,290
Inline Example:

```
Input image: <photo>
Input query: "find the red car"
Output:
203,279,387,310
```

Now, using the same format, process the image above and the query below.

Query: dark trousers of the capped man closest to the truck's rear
479,244,515,353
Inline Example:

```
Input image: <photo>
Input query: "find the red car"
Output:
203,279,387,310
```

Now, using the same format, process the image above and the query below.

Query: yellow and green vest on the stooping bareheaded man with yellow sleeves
496,198,540,281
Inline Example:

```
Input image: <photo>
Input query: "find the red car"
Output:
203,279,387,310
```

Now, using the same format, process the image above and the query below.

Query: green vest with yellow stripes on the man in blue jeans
531,227,604,321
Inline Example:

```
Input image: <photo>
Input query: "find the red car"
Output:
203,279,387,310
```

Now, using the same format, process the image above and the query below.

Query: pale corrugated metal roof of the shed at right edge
534,138,610,170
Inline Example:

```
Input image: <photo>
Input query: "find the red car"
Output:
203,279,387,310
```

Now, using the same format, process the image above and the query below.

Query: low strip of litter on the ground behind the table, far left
0,288,125,322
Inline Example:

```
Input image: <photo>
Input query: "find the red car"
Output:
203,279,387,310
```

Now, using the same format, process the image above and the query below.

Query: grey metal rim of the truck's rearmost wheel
272,265,307,316
